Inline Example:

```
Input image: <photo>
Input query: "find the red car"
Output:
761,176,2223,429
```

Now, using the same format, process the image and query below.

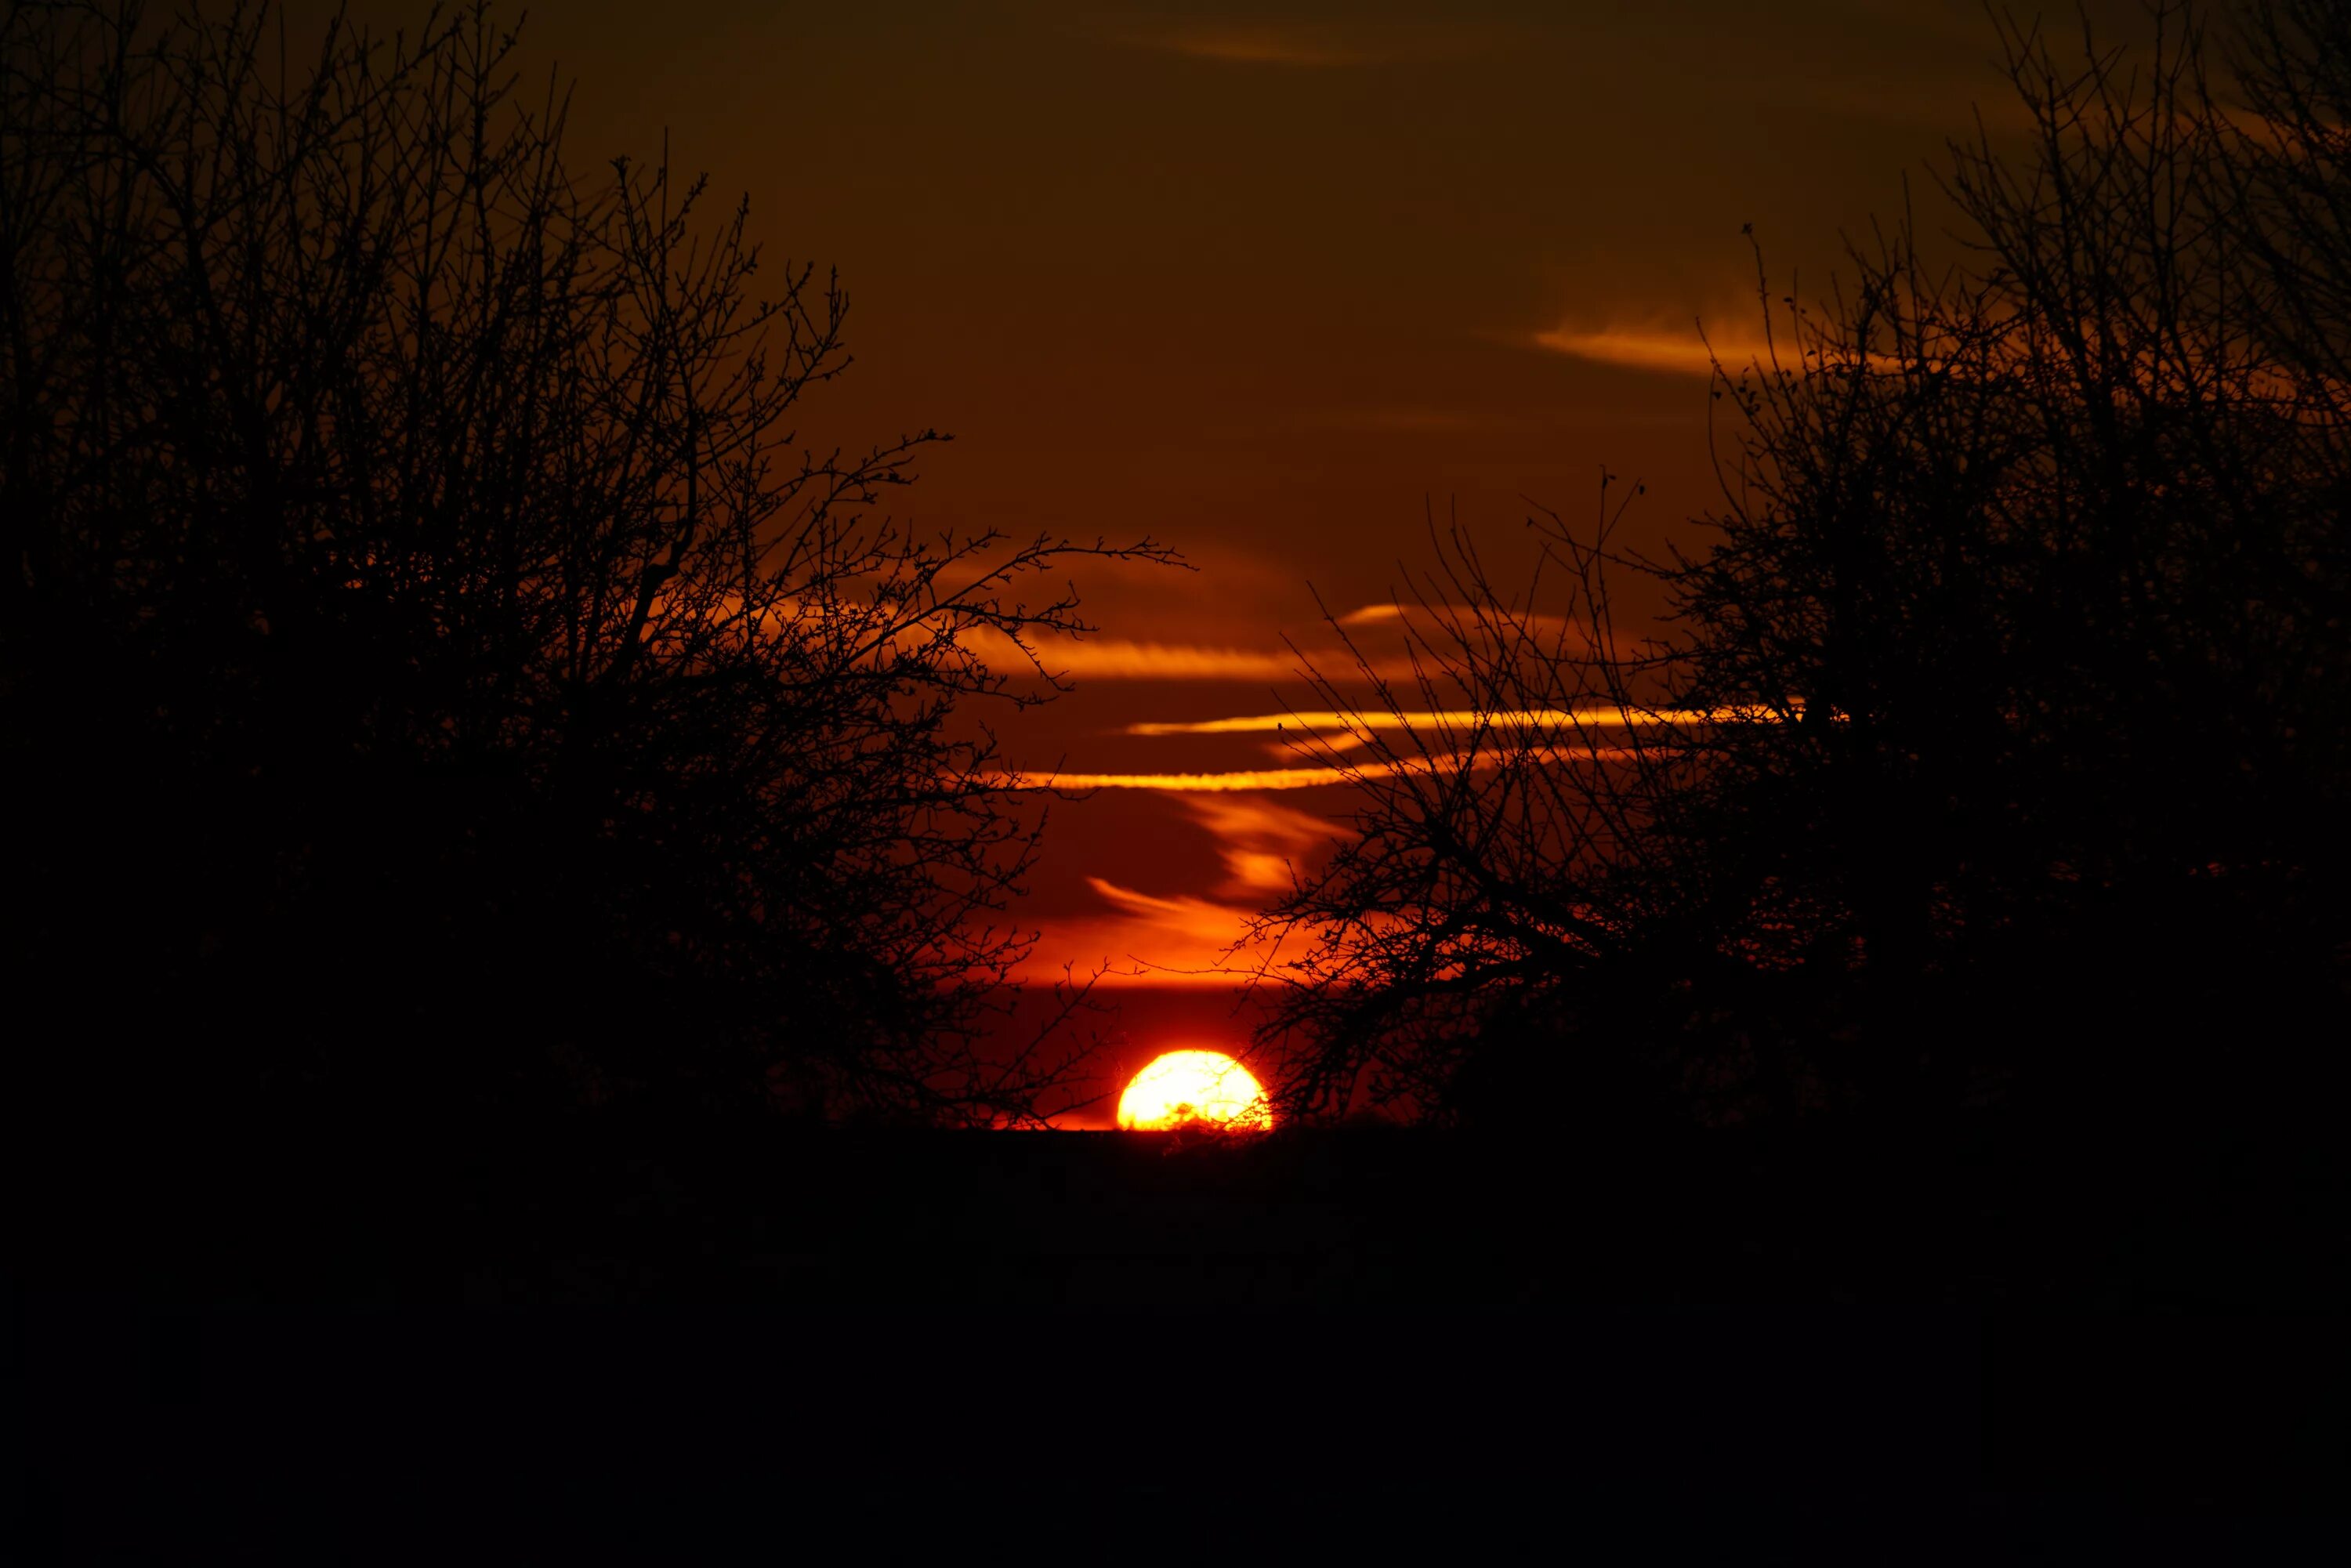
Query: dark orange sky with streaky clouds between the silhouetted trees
327,0,2130,1119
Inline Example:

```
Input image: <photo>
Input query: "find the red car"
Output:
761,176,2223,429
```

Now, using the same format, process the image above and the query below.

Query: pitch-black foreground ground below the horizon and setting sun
7,1121,2351,1561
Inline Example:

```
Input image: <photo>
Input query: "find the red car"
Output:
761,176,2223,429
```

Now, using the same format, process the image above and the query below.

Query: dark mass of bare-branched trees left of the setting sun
0,5,1161,1121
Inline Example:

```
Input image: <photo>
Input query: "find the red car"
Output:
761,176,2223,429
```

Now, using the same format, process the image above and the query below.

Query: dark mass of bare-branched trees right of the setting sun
1270,0,2351,1126
